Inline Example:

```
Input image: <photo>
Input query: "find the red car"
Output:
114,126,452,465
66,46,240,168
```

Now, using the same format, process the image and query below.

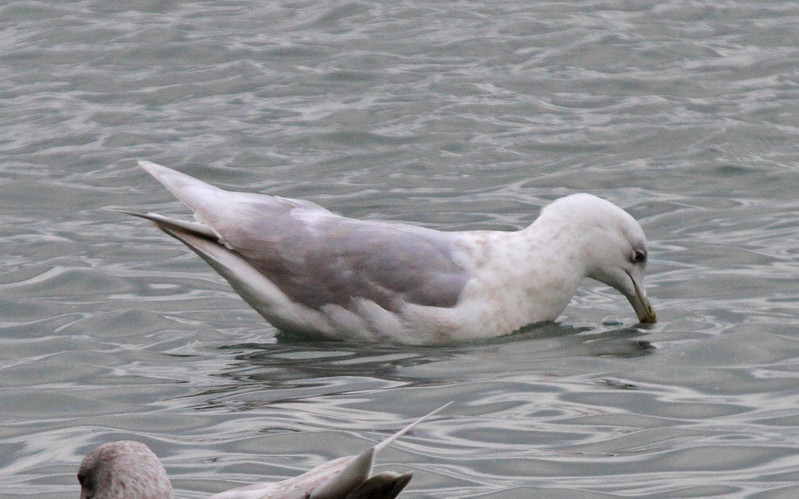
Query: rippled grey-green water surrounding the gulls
0,0,799,498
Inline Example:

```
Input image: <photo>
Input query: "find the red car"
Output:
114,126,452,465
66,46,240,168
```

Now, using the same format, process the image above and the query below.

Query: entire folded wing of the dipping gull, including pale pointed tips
140,162,468,311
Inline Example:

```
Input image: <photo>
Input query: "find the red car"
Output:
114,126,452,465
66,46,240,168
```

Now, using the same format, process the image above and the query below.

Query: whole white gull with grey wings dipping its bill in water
131,161,656,344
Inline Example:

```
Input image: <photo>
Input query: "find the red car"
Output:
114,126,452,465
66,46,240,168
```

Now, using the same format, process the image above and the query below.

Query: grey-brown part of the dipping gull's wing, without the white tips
217,204,468,310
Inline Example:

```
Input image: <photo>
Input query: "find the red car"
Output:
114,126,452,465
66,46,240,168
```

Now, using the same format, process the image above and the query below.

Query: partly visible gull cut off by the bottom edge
78,402,451,499
